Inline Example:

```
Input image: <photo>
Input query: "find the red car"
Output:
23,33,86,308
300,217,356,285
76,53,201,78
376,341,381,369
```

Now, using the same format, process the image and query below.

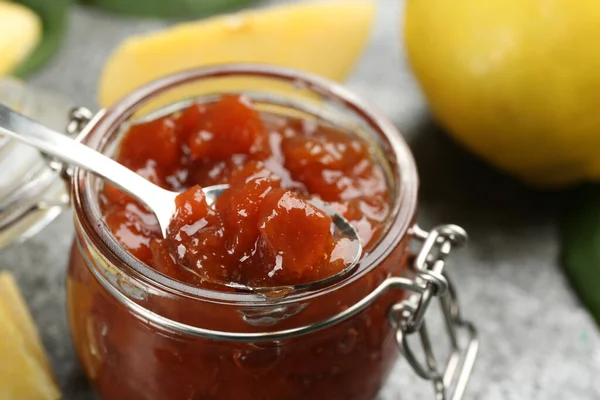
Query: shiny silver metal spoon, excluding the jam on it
0,105,362,291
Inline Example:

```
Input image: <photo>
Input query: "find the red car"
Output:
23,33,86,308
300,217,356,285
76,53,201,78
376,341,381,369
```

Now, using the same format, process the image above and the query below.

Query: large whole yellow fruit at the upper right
405,0,600,186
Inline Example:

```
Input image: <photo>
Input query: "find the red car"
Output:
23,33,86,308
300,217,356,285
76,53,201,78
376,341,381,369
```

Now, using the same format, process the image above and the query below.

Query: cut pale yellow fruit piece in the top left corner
0,1,42,76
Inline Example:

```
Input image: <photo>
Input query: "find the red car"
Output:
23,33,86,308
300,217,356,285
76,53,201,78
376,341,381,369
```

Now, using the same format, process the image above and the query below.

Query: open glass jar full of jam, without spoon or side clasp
67,66,426,400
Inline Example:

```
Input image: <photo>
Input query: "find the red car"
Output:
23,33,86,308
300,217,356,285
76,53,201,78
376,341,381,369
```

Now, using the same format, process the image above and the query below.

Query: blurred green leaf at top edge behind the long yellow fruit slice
80,0,256,19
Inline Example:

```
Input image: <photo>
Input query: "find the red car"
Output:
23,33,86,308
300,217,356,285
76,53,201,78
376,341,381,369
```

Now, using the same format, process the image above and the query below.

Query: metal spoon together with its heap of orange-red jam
0,105,362,291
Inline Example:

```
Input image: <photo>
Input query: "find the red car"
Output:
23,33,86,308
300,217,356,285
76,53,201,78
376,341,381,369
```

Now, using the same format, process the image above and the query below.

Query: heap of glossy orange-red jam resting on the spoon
166,183,349,287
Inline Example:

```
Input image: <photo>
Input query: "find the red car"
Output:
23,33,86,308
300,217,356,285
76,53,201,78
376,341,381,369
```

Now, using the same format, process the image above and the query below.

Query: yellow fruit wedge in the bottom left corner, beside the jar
0,272,60,400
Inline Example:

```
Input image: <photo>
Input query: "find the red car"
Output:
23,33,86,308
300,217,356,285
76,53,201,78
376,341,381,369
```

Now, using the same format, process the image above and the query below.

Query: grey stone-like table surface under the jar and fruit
0,0,600,400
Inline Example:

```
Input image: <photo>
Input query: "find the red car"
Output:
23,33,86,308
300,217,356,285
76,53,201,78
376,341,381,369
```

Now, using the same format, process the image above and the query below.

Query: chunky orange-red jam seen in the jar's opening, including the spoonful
102,95,389,287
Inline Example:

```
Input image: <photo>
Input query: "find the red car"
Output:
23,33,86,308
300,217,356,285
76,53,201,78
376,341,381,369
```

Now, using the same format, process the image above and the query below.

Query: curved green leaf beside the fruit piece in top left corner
10,0,71,78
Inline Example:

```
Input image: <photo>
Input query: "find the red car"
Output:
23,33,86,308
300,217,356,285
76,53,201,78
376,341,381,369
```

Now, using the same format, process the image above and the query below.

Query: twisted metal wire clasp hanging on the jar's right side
389,225,479,400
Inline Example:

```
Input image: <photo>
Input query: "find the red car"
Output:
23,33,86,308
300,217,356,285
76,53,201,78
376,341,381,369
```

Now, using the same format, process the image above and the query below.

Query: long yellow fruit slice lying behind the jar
99,0,374,106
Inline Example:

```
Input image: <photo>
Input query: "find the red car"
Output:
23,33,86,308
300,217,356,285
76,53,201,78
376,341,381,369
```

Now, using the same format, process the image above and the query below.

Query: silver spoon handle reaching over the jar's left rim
0,105,170,209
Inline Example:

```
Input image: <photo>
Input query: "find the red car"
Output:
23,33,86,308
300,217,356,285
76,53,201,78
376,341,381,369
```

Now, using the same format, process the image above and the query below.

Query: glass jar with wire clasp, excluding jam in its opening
1,65,478,400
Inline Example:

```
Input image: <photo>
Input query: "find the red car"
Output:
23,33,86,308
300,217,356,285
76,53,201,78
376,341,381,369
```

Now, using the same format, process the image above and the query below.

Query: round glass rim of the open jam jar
72,64,418,304
